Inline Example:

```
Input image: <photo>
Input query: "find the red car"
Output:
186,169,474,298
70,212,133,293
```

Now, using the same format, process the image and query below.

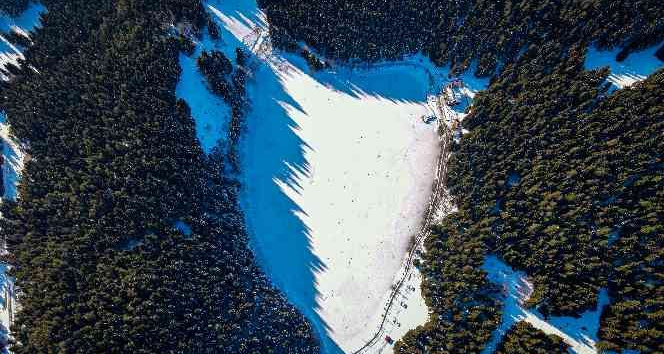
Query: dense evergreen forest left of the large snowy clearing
0,0,319,354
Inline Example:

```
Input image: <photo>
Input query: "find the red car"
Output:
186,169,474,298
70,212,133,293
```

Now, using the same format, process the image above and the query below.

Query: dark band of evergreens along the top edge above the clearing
258,0,664,76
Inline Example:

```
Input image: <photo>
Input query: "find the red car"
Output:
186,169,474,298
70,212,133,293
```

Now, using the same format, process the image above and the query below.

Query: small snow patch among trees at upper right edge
585,43,664,89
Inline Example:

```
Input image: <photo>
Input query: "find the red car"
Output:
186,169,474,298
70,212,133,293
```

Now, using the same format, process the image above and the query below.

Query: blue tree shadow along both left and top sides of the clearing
206,0,456,354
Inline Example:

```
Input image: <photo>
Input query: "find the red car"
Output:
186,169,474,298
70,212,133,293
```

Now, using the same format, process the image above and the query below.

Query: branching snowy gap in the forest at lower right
482,255,609,354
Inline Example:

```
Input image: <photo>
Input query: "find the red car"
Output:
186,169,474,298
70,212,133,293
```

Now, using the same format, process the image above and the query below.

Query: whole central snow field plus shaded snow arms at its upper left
177,0,478,353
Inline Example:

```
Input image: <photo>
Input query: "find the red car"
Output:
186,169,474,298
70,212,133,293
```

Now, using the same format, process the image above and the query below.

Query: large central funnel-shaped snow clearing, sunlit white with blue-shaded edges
252,62,439,352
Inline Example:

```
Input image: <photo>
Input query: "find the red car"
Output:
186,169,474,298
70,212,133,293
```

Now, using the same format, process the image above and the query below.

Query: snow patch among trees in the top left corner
0,2,46,80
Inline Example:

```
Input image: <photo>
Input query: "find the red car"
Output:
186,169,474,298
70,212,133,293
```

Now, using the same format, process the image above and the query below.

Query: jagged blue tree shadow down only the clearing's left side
207,1,342,354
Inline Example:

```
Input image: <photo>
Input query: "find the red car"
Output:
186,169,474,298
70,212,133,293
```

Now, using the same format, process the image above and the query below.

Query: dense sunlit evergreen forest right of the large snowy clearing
395,43,664,354
